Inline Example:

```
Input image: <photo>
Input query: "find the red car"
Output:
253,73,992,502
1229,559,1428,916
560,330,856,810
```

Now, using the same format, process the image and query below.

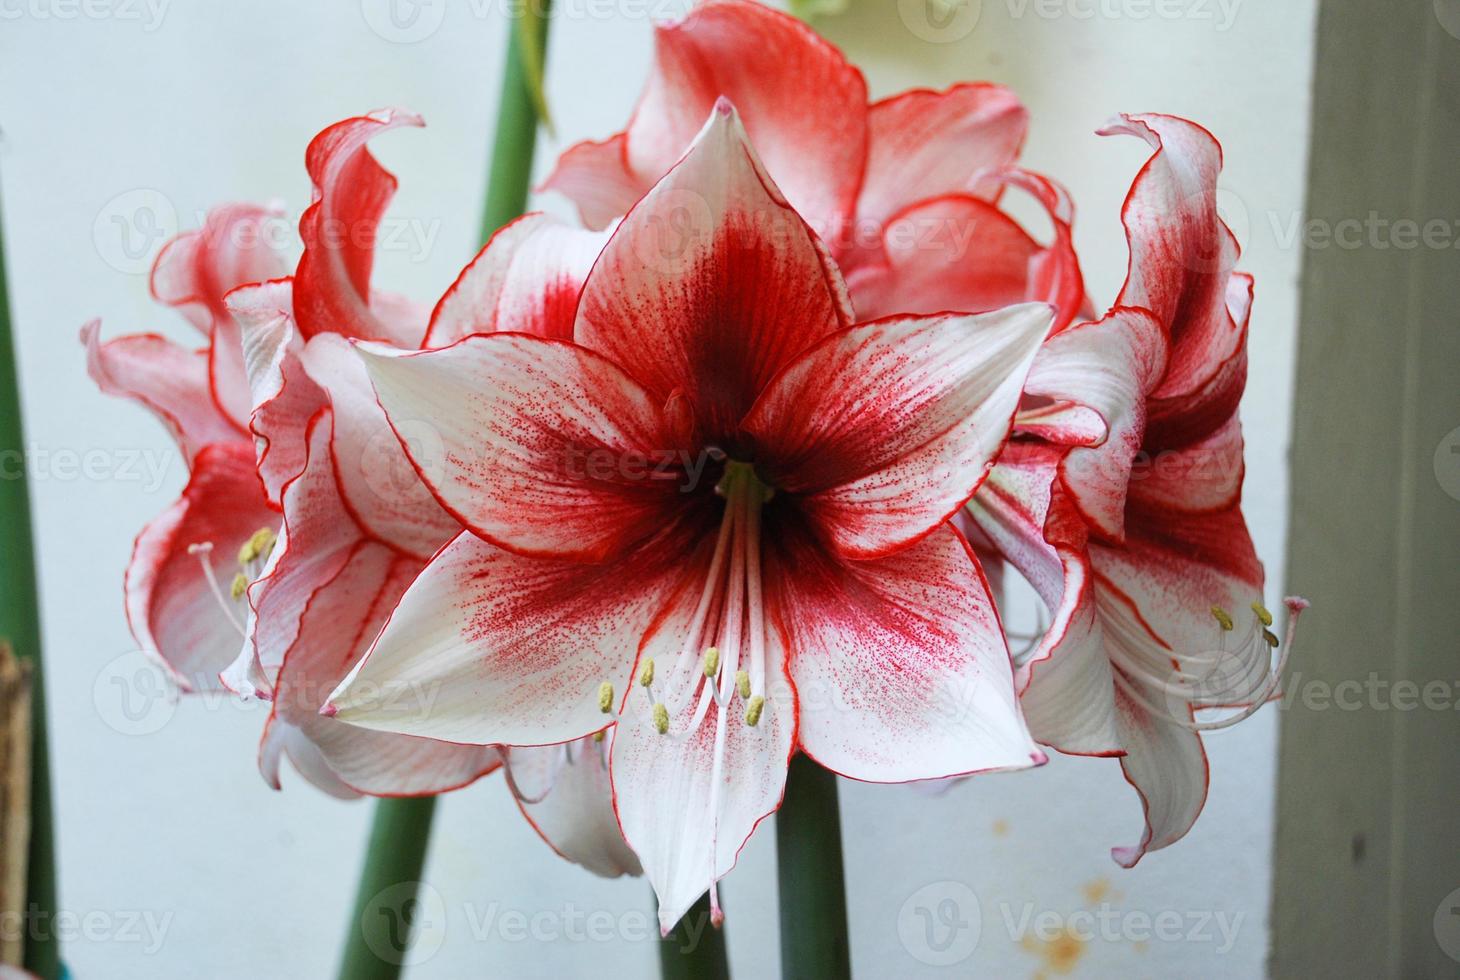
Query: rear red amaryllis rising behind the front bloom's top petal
545,0,1083,327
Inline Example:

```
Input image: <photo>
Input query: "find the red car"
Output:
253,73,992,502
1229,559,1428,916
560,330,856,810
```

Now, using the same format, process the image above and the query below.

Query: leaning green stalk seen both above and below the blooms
339,0,549,980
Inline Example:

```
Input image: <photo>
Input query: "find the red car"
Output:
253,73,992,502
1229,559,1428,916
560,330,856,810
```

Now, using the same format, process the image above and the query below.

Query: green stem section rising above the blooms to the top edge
482,0,552,242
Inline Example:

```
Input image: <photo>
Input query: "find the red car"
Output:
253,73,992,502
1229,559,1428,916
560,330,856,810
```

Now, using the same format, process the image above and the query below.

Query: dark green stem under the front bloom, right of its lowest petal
775,755,851,980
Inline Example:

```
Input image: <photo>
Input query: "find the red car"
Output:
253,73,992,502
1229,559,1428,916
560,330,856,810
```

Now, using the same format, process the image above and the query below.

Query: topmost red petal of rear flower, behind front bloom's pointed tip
626,0,867,235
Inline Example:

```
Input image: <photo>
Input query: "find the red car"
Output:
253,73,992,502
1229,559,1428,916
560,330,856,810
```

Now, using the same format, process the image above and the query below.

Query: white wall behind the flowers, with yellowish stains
0,0,1314,980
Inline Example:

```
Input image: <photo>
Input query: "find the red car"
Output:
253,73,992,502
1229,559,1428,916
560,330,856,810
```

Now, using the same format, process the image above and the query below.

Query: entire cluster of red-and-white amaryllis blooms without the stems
83,0,1304,927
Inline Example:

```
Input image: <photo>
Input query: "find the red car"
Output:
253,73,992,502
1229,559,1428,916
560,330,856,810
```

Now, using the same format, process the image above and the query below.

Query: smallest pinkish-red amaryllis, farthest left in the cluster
82,204,285,691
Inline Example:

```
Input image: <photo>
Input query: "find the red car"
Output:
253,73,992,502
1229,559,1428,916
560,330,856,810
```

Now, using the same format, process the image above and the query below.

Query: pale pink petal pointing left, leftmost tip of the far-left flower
80,320,244,466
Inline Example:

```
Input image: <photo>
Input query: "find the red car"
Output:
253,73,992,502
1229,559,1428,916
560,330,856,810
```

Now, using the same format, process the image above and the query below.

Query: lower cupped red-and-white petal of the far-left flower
126,441,277,691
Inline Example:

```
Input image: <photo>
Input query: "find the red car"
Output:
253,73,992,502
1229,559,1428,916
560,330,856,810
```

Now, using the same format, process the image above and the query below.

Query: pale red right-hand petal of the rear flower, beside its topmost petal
857,82,1029,233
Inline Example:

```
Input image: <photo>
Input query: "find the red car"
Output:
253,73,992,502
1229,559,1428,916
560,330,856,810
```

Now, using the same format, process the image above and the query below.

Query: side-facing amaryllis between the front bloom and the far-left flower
213,110,638,875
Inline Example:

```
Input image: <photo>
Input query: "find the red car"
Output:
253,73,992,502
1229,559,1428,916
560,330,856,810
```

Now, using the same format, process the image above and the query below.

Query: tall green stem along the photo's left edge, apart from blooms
0,180,61,980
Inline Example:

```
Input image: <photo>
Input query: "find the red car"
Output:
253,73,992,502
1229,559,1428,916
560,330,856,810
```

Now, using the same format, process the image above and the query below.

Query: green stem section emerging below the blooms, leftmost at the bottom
340,796,437,980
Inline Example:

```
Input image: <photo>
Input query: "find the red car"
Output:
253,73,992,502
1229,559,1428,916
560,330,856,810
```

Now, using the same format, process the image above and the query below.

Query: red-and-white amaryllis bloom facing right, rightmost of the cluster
968,115,1307,866
